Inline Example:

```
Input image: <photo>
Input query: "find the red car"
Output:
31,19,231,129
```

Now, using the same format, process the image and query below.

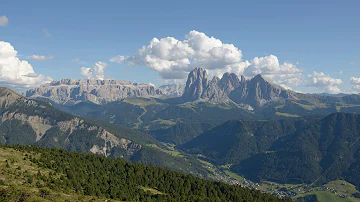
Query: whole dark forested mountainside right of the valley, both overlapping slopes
179,113,360,186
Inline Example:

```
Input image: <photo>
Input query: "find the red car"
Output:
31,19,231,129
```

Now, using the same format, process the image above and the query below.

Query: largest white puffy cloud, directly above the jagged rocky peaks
110,30,247,79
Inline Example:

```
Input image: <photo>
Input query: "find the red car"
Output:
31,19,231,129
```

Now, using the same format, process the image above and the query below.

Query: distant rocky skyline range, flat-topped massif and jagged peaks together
22,68,360,109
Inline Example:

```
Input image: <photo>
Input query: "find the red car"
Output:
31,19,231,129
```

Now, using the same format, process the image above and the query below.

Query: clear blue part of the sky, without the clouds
0,0,360,92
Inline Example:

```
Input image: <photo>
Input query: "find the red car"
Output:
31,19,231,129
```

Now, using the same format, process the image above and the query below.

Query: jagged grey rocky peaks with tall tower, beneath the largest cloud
182,68,295,107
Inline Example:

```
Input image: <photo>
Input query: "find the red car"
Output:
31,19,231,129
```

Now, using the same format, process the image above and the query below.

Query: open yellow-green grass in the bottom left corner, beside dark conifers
0,148,121,202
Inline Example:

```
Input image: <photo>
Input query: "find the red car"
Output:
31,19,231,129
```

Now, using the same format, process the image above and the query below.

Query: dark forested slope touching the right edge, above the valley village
233,113,360,186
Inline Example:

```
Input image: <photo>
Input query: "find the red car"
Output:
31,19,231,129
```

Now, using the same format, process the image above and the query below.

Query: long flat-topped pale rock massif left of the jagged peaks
23,79,163,104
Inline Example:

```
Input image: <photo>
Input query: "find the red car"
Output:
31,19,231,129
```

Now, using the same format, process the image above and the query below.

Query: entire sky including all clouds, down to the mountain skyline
0,0,360,93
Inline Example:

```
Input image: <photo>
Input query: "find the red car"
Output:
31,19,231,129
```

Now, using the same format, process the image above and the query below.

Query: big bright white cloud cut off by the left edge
0,41,52,91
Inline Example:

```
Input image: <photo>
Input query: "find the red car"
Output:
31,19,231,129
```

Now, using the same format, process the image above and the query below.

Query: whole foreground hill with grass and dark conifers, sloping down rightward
0,146,290,202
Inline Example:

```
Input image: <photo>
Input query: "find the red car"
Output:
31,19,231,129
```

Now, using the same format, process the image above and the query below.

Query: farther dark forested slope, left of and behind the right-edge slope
179,118,316,165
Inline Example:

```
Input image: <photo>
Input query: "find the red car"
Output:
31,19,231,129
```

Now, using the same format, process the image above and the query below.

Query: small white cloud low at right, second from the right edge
307,71,343,93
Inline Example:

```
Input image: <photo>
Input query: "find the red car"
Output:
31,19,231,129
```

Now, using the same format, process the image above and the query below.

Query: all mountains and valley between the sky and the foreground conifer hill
0,68,360,200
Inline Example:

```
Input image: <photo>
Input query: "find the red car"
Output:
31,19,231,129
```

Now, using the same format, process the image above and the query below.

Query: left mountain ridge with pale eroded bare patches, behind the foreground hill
0,88,207,176
